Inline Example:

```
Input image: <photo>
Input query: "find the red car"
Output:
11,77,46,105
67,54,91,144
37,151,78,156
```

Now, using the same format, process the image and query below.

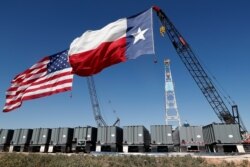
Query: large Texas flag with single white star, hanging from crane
68,8,154,76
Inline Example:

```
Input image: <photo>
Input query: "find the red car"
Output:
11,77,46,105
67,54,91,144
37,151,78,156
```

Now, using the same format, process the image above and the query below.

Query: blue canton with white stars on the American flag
47,50,70,74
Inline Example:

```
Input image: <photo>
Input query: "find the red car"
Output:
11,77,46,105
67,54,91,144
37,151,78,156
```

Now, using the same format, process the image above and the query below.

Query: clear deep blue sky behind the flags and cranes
0,0,250,129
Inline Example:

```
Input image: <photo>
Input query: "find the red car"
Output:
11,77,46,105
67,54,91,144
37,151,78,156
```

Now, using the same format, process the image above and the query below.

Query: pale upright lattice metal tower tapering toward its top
164,59,181,126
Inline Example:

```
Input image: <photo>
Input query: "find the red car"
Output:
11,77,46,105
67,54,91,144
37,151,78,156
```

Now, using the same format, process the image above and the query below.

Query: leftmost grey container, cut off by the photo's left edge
0,129,14,151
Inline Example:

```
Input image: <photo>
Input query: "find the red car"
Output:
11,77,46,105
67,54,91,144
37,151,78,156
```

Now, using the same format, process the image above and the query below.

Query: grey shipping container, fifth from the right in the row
96,126,123,152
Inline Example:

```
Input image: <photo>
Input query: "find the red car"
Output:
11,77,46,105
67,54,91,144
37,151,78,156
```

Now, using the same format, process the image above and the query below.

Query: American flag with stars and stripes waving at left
3,50,73,112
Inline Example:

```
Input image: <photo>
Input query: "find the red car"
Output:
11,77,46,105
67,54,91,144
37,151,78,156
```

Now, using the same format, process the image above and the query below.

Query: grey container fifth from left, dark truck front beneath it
72,126,97,152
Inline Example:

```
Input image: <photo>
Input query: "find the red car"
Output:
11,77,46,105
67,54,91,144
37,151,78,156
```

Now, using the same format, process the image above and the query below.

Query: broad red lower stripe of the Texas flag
69,38,126,76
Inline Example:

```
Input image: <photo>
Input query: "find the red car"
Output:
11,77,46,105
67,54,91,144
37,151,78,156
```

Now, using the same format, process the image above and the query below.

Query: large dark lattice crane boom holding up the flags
154,7,247,132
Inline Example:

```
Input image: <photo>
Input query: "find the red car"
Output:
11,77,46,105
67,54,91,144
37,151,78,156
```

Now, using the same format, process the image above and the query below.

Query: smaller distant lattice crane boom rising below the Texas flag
87,76,107,126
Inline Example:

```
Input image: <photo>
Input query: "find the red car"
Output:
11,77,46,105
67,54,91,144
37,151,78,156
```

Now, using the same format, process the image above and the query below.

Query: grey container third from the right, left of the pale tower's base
150,125,173,145
